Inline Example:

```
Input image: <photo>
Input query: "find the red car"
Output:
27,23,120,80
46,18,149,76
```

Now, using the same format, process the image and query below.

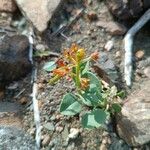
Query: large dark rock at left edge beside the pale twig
0,35,32,87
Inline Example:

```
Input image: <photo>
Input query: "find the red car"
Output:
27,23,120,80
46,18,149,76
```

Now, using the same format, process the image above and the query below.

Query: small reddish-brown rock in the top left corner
0,0,17,12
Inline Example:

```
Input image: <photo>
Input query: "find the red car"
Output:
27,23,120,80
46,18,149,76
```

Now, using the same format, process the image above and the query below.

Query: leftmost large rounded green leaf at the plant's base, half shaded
60,93,82,116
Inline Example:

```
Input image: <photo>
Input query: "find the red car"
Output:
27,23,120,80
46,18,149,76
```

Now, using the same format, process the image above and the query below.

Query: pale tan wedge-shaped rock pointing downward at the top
16,0,62,32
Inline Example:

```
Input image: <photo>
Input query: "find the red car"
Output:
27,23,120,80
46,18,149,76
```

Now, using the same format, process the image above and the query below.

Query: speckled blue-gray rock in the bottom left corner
0,126,35,150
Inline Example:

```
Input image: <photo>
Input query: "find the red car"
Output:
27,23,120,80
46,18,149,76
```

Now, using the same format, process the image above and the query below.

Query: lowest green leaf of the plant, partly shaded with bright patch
81,109,108,129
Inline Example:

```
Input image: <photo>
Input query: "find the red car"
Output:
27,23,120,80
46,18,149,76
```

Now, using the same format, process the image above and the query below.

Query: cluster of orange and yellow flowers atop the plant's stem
50,44,99,89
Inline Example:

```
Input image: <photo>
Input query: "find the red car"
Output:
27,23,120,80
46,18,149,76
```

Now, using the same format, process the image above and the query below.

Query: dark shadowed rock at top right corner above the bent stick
106,0,150,20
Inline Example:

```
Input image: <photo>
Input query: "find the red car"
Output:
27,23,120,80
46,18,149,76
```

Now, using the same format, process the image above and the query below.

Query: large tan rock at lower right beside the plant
117,80,150,146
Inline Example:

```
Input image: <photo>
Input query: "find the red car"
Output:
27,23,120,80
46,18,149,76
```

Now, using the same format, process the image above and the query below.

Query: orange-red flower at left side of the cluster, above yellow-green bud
53,66,70,77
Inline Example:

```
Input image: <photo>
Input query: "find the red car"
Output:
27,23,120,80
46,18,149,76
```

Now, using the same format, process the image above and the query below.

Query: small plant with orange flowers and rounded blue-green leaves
44,44,121,128
